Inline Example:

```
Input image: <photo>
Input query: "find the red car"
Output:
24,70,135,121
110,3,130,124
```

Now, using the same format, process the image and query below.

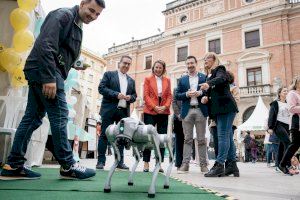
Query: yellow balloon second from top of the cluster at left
9,8,30,31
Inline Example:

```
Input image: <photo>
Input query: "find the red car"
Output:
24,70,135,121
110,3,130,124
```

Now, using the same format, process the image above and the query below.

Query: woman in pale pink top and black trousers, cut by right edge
279,76,300,175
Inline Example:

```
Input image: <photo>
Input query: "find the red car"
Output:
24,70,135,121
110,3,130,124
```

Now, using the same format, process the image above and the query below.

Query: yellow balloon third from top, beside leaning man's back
13,29,34,52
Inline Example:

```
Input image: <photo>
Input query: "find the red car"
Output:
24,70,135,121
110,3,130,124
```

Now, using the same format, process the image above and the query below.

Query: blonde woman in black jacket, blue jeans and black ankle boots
201,53,239,177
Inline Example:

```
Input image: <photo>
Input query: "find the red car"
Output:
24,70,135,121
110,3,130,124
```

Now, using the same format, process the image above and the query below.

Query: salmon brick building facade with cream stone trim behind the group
104,0,300,123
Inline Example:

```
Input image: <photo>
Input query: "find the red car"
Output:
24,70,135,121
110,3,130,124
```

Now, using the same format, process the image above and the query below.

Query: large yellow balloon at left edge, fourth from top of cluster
0,48,22,73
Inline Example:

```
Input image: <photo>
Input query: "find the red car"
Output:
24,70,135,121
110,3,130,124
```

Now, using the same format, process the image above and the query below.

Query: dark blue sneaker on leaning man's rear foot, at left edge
0,164,41,180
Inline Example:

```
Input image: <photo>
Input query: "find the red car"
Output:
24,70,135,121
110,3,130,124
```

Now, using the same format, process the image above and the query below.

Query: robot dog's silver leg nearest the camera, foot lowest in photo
148,134,161,198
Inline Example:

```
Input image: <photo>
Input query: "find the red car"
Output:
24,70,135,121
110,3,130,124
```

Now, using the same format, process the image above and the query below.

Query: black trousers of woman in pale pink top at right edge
280,129,300,167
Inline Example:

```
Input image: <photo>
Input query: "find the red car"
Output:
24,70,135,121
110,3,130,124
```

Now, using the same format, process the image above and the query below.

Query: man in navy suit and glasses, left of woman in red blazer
96,56,137,170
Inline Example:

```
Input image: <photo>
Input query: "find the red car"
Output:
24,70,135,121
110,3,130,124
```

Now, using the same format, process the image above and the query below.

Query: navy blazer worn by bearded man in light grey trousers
175,73,208,119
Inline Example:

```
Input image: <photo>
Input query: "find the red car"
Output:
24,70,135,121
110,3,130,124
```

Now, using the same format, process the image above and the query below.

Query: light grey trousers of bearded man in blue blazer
182,108,208,167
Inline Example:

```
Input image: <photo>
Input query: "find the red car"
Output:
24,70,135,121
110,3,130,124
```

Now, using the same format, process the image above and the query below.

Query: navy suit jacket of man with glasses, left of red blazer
98,71,137,118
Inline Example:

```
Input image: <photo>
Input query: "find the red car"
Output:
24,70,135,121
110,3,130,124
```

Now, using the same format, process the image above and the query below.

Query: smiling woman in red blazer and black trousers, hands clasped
143,60,172,172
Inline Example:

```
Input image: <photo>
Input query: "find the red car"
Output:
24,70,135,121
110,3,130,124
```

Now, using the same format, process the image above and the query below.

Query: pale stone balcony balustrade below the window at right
240,84,272,97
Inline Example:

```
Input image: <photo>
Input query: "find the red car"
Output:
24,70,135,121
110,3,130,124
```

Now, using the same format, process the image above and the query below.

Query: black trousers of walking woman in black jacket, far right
274,122,291,167
